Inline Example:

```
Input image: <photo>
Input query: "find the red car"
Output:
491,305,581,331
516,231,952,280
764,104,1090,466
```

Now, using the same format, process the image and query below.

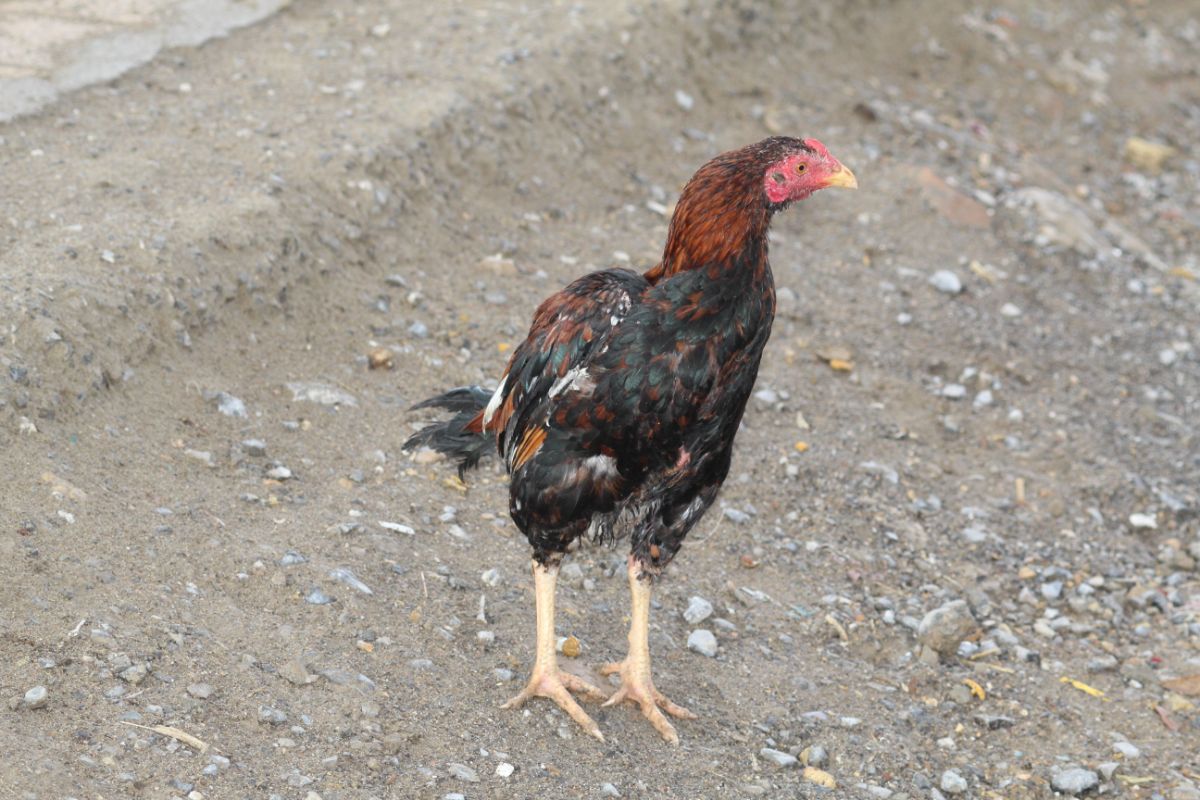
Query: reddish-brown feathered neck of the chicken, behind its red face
646,154,772,283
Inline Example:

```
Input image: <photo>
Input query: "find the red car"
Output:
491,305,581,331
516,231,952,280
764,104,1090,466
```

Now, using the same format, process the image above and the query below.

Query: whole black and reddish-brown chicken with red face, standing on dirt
406,137,857,742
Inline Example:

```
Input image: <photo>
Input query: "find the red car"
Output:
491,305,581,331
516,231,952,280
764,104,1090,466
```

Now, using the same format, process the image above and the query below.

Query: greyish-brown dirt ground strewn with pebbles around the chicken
0,0,1200,800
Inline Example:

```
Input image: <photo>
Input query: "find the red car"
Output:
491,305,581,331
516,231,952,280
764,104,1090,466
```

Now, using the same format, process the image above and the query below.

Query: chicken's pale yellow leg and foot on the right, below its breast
600,555,697,745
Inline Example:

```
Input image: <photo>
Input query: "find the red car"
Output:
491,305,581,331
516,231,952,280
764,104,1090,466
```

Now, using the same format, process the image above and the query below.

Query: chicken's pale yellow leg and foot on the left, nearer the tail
500,561,606,741
